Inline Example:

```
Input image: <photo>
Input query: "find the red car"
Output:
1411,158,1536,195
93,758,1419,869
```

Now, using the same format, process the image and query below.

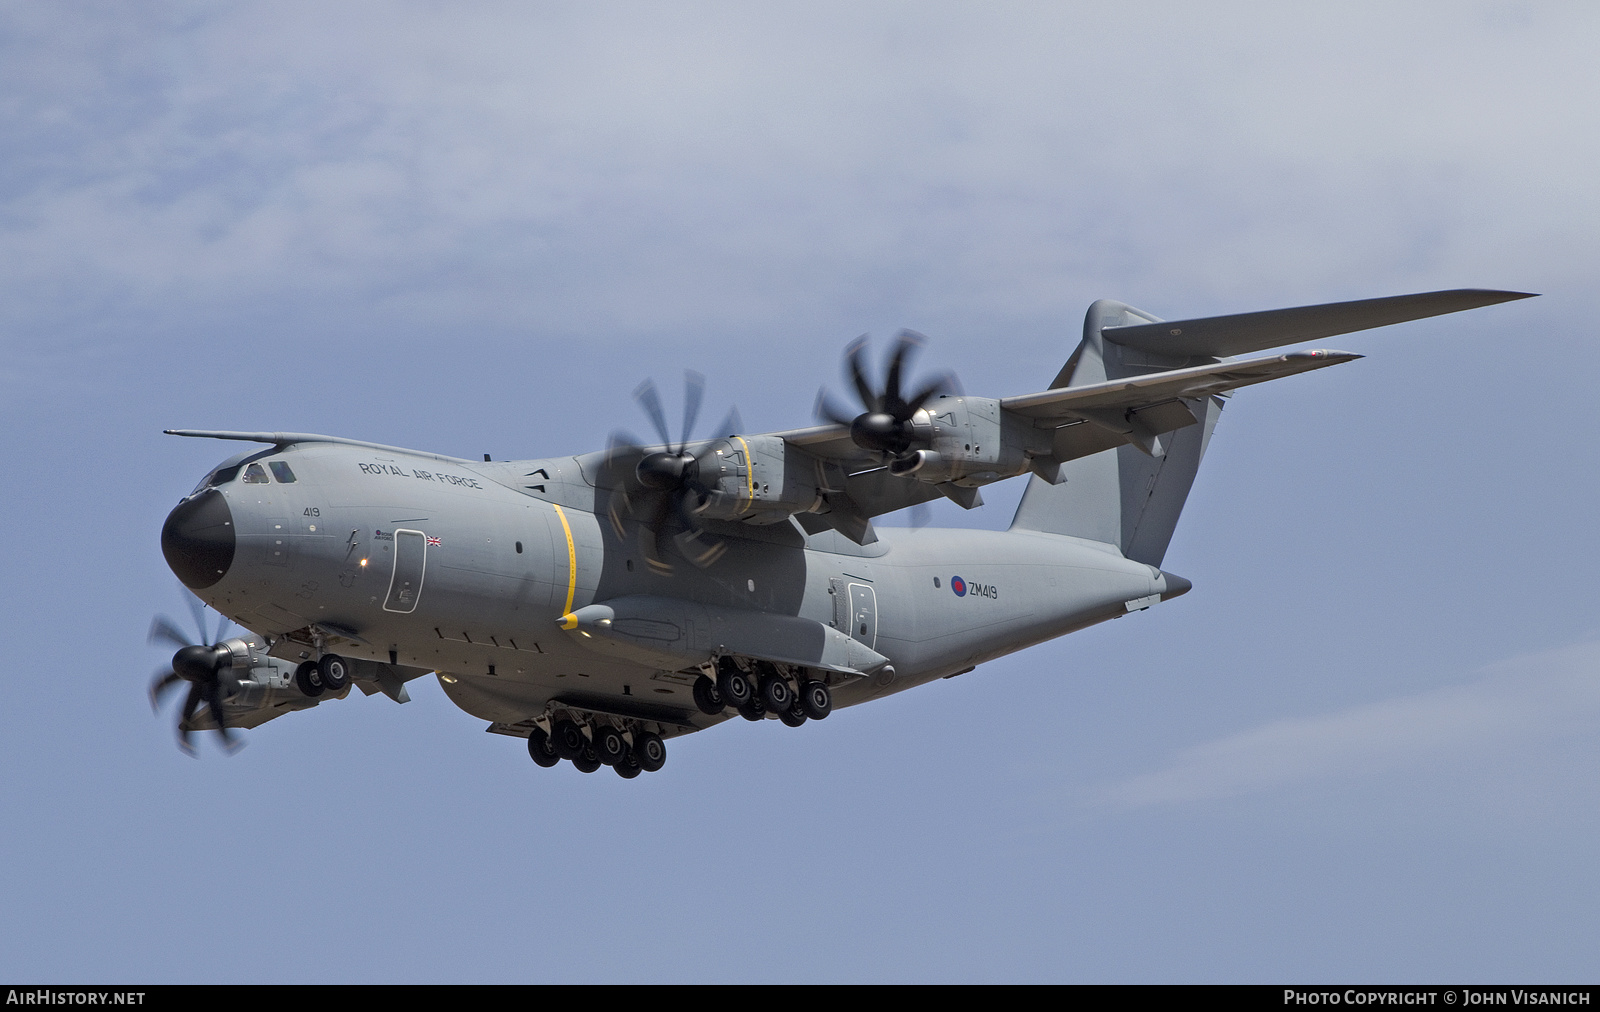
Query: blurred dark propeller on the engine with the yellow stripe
606,371,742,573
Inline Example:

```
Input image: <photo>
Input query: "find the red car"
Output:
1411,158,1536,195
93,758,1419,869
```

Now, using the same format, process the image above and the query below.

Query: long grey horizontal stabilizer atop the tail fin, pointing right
1101,288,1533,359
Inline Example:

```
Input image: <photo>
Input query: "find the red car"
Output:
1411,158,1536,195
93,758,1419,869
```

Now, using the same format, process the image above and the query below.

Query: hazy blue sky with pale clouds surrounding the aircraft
0,3,1600,982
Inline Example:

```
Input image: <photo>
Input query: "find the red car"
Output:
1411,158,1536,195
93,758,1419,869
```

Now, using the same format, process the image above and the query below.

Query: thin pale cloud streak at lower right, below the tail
1102,642,1600,807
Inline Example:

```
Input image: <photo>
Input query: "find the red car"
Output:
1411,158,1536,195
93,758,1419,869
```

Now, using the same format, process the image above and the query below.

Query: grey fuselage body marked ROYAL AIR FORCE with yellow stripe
170,444,1187,732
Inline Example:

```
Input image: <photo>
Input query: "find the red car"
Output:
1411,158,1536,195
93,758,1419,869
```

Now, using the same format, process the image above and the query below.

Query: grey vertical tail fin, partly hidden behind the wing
1011,299,1224,567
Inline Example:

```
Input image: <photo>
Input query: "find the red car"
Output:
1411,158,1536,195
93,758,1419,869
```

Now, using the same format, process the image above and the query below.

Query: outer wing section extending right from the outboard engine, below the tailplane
1000,351,1362,424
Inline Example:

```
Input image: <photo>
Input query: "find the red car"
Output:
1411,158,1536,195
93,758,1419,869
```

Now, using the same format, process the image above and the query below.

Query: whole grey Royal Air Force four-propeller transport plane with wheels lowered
150,290,1528,777
